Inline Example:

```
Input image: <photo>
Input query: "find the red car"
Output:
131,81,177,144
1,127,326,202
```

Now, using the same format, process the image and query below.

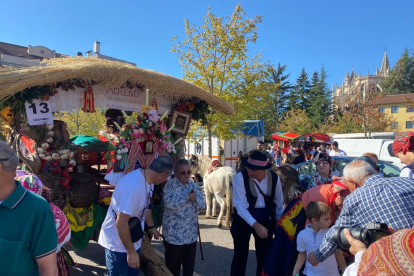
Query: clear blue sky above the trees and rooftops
0,0,414,86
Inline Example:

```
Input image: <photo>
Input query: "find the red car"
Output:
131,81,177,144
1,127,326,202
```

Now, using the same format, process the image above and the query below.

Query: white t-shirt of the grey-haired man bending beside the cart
98,170,154,253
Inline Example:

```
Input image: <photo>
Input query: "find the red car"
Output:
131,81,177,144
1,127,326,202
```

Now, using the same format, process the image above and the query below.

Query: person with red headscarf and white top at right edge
392,131,414,178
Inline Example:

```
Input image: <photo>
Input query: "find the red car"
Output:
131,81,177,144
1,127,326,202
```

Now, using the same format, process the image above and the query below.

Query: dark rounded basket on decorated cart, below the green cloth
69,173,98,208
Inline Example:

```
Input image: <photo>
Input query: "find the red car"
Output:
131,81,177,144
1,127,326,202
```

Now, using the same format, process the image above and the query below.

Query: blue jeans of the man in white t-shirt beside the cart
105,247,141,276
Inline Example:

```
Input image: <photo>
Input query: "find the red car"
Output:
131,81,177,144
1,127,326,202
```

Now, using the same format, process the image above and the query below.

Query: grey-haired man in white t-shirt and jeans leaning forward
98,156,174,276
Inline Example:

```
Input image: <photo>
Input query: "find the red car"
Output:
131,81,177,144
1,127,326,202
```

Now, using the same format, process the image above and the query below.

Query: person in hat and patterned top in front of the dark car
308,152,339,189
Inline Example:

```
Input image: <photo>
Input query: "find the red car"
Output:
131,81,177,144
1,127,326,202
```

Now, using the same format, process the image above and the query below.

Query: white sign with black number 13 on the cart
26,100,53,126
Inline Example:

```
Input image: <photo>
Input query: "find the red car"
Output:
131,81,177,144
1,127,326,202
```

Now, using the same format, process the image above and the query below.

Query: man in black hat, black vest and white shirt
230,151,283,276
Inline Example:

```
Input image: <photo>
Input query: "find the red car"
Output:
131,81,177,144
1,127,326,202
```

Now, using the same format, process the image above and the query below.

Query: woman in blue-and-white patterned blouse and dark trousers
162,159,205,276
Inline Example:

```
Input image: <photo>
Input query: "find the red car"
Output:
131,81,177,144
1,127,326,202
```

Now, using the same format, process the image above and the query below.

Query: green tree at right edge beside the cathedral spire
382,48,414,94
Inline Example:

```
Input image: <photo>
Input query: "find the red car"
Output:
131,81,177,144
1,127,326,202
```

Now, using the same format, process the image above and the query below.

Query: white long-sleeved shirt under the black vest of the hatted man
233,172,283,226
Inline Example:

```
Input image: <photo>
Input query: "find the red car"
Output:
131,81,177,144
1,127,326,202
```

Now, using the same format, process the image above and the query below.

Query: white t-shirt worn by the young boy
297,224,339,276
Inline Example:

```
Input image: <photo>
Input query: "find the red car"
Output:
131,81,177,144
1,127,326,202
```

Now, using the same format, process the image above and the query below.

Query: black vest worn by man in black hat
242,170,278,220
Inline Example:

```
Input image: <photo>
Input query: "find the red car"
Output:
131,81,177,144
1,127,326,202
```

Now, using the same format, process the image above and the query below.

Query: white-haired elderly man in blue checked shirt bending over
308,161,414,266
